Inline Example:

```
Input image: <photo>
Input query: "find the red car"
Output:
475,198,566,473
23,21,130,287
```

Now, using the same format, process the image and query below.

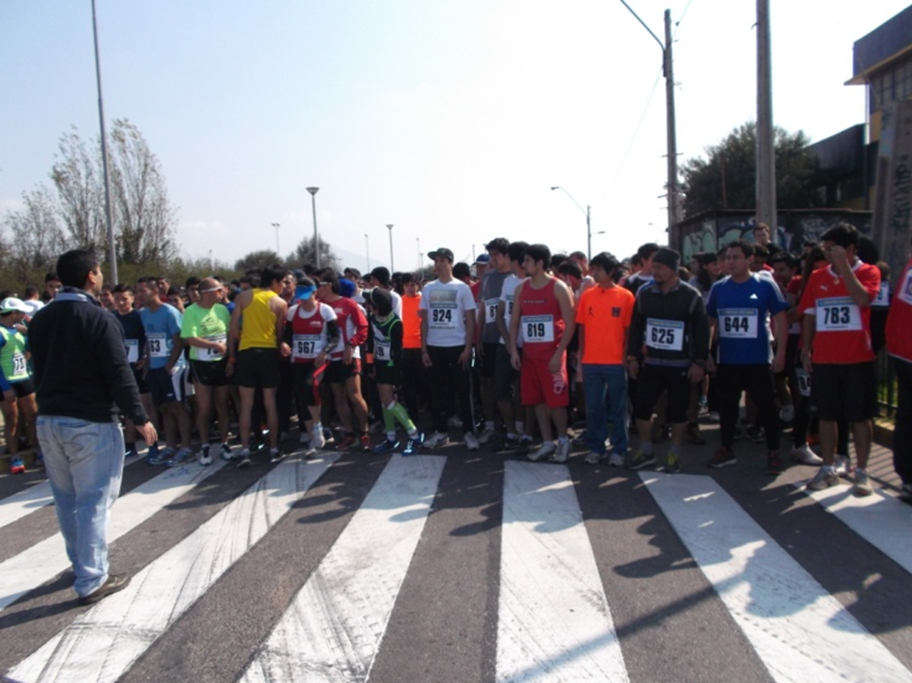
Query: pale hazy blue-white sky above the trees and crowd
0,0,908,270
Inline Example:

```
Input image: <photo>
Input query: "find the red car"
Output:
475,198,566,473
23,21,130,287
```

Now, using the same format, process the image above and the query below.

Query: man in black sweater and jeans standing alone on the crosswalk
29,250,158,604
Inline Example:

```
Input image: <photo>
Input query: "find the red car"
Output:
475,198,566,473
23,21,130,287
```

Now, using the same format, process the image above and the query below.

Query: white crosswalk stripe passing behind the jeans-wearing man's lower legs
0,460,225,609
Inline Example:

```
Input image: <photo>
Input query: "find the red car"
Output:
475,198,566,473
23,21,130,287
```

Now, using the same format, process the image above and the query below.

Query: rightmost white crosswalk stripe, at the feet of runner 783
799,480,912,574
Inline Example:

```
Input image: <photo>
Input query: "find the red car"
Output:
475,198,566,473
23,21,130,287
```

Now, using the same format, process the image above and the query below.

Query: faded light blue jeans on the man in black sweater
38,415,124,597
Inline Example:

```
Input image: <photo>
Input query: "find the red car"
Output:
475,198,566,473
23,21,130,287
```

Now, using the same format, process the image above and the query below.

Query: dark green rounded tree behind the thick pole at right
681,121,820,215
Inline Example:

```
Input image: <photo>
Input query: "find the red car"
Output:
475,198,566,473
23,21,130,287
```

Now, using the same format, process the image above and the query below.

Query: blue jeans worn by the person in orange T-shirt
583,363,628,455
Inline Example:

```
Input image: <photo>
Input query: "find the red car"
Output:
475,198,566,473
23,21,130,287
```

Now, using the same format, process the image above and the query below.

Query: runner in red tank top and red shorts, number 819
510,244,576,462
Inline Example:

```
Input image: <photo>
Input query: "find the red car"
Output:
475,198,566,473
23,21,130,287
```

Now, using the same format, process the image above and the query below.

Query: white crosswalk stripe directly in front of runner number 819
497,461,628,682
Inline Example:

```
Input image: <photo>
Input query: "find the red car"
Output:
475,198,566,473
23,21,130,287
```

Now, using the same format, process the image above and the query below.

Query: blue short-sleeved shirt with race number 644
706,275,788,365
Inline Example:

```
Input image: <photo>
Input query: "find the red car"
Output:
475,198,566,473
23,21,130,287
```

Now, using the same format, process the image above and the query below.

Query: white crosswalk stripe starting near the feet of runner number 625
640,472,912,683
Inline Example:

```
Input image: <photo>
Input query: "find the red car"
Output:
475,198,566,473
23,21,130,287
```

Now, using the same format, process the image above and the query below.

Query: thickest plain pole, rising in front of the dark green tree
757,0,778,231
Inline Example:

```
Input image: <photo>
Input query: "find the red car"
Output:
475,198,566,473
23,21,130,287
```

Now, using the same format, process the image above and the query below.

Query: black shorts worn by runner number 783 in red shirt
811,361,878,422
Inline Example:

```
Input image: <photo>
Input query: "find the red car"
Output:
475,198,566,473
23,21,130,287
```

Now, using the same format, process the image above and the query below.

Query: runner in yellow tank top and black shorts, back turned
227,266,292,467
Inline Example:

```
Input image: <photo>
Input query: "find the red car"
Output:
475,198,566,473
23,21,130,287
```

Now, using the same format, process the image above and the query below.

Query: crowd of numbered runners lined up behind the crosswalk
0,224,912,499
